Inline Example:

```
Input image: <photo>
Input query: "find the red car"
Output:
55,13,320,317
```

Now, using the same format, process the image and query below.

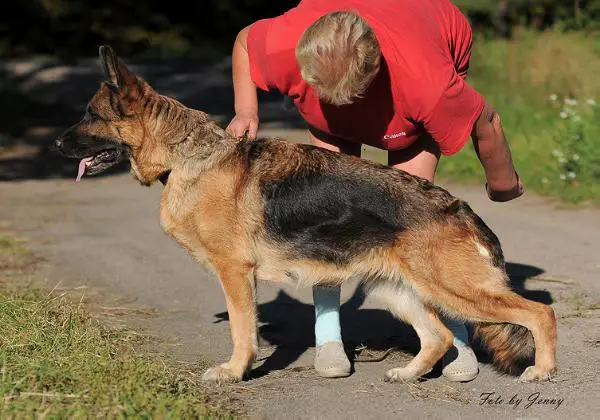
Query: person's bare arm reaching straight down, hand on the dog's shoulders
227,26,258,139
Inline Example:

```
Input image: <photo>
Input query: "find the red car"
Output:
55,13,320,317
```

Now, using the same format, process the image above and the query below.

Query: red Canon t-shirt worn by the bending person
247,0,484,155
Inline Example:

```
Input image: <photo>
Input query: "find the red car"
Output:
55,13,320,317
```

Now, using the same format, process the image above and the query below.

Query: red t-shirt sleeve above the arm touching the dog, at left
246,19,274,91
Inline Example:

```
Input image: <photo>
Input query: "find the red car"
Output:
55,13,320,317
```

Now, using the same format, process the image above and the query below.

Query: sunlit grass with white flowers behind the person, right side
440,31,600,204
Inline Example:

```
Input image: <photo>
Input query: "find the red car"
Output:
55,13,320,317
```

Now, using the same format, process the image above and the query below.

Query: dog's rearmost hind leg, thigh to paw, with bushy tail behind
388,223,556,382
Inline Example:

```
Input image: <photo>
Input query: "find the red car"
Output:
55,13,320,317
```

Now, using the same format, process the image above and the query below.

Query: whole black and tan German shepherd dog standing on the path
56,46,556,382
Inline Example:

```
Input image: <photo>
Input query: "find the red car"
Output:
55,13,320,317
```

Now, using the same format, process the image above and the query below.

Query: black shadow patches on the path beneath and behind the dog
215,263,553,378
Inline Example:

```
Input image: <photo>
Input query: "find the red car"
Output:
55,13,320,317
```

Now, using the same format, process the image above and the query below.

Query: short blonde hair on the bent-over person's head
296,11,381,105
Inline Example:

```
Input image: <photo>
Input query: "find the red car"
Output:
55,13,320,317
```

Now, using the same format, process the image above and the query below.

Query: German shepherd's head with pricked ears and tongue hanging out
55,46,177,185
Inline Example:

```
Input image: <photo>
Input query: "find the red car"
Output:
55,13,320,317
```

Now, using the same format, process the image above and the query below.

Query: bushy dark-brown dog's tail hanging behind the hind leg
473,323,535,374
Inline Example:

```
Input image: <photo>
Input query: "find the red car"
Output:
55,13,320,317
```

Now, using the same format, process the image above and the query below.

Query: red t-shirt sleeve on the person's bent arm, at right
423,69,485,156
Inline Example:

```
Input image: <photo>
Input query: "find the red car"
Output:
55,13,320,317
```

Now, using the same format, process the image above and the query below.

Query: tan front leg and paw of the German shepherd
202,260,258,382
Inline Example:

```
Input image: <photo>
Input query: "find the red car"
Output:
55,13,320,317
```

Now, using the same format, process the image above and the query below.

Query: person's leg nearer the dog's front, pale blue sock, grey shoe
309,129,361,378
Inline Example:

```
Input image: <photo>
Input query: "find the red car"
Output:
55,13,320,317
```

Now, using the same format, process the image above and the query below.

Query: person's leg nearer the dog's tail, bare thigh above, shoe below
388,136,479,382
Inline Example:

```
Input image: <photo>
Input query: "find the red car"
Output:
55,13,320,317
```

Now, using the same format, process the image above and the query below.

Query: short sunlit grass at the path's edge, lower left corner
0,236,231,418
